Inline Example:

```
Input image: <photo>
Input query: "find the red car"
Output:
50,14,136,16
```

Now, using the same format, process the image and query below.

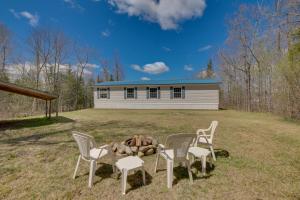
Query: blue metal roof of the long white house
95,79,221,86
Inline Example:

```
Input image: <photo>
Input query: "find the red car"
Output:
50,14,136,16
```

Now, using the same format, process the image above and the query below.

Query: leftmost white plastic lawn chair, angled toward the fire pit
72,131,115,187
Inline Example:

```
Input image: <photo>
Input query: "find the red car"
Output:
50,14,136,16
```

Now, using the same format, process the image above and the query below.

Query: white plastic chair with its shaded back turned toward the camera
154,134,196,188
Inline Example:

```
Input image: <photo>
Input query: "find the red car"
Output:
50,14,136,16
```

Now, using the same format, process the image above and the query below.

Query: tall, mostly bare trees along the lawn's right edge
218,0,300,119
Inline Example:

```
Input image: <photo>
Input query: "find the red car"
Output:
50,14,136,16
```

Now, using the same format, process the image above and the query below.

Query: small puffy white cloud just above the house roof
131,62,170,74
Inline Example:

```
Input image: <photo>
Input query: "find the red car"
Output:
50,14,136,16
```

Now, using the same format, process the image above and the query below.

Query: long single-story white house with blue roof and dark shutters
94,79,220,110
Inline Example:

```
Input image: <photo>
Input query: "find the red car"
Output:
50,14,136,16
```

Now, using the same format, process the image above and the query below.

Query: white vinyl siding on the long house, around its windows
95,84,219,109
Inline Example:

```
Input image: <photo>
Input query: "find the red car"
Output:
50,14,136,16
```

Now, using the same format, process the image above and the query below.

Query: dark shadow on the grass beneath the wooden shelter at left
0,116,74,131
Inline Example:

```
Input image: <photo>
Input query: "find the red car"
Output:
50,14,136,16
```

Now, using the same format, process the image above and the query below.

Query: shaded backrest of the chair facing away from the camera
165,133,196,162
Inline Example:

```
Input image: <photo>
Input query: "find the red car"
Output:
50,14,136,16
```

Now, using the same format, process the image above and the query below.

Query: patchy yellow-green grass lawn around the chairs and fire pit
0,109,300,200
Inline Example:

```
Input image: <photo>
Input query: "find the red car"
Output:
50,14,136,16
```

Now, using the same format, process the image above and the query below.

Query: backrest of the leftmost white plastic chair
72,131,94,159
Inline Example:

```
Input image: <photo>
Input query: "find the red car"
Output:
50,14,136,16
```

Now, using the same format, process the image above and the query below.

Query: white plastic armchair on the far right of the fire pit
194,121,219,161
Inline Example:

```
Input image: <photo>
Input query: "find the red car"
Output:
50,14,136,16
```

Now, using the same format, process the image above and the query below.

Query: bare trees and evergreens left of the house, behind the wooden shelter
0,23,124,118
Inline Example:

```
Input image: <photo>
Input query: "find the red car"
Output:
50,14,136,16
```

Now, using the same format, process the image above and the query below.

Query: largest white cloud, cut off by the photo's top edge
108,0,206,30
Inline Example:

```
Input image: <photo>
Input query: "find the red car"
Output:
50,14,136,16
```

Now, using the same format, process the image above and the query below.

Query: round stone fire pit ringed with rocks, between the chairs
111,135,158,157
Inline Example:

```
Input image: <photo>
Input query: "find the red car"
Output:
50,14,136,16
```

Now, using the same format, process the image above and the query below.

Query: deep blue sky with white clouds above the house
0,0,264,80
